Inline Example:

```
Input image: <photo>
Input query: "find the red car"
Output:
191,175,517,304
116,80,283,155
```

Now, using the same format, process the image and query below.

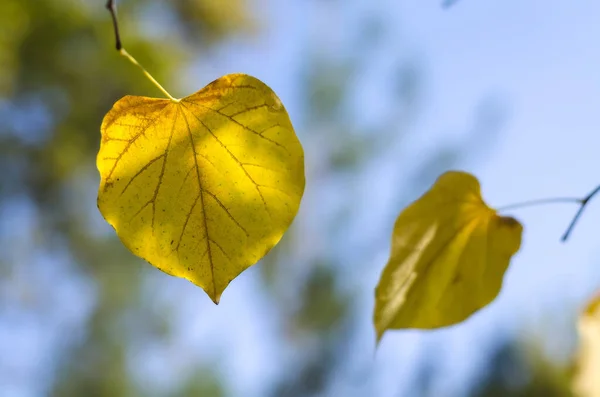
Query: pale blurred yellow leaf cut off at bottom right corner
573,295,600,397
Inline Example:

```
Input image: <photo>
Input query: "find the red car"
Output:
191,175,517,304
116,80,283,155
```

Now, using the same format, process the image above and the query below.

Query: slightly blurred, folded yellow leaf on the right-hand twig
374,171,523,341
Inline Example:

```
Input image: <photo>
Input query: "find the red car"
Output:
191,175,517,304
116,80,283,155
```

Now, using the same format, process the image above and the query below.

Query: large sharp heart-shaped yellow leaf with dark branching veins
97,74,304,303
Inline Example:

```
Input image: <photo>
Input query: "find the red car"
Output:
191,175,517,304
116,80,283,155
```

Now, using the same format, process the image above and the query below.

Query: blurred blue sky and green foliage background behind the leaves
0,0,600,397
